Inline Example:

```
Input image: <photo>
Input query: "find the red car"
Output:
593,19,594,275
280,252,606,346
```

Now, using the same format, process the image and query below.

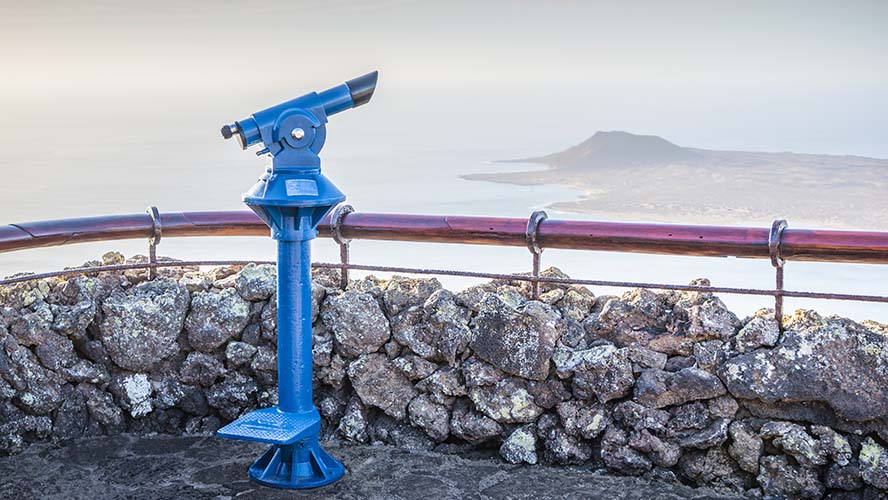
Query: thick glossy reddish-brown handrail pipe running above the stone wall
0,211,888,264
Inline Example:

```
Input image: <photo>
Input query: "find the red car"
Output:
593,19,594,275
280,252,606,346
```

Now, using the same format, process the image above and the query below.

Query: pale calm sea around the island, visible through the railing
0,124,888,322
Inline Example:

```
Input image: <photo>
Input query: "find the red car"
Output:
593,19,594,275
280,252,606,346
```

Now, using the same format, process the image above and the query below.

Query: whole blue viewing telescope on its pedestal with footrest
217,71,377,488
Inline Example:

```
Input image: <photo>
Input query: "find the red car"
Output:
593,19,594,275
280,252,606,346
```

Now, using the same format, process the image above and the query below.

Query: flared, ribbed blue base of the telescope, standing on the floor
250,437,345,489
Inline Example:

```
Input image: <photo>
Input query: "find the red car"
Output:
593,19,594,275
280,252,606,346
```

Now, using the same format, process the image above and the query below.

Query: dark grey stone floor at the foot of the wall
0,435,737,500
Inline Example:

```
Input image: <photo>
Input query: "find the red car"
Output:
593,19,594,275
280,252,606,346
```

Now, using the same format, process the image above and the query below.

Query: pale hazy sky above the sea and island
0,0,888,157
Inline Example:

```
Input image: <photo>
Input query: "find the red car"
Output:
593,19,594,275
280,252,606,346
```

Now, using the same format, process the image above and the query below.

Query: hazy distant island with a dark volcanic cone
463,131,888,230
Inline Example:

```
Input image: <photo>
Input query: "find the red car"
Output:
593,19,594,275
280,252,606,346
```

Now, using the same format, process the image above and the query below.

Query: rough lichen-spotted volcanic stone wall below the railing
0,253,888,498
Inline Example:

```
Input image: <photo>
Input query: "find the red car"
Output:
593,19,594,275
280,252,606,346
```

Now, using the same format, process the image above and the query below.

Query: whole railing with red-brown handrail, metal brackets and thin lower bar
0,205,888,326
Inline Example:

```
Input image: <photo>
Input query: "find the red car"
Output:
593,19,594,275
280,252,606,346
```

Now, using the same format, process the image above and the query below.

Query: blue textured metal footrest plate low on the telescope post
216,406,321,445
